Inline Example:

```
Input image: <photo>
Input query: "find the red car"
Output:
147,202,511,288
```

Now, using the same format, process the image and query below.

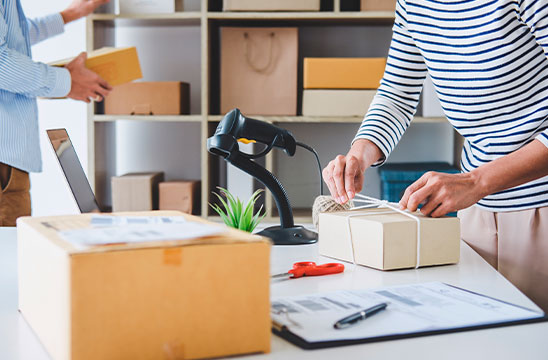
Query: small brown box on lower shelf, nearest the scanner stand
160,181,201,215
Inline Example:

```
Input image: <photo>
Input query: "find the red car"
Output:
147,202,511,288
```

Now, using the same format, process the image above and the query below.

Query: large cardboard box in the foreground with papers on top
17,212,271,360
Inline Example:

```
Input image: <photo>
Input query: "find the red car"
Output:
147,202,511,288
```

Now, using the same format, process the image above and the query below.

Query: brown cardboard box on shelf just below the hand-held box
105,81,190,115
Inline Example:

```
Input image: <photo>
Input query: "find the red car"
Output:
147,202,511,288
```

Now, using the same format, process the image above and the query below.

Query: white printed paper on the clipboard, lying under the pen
271,282,543,343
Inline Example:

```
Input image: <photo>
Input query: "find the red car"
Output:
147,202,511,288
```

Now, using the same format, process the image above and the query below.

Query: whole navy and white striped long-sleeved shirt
355,0,548,211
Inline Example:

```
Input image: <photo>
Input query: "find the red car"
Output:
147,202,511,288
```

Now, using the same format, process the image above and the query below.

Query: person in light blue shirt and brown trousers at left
0,0,111,226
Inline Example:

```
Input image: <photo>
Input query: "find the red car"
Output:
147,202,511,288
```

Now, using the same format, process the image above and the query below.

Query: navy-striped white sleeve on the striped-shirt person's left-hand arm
353,0,427,166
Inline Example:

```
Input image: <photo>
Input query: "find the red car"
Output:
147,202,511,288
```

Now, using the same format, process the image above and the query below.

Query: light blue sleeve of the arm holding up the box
0,5,71,97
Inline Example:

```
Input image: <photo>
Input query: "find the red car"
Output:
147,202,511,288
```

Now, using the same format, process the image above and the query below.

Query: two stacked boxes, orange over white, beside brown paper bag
302,58,386,117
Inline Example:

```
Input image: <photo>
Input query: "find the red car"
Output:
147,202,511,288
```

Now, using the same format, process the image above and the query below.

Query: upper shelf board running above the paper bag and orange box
207,11,394,20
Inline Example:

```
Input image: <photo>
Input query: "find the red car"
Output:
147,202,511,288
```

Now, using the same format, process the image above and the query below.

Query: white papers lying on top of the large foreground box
59,215,225,248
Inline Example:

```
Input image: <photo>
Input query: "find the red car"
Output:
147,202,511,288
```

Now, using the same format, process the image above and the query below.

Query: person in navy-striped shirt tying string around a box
324,0,548,311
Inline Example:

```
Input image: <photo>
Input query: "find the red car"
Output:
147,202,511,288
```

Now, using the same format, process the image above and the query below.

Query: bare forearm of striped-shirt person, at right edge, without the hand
470,140,548,198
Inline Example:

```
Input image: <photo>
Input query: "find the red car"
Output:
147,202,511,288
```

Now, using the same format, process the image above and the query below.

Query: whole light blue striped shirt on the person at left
0,0,71,172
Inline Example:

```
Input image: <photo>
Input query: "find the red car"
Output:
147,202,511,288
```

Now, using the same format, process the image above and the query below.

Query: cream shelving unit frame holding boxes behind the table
86,0,454,221
